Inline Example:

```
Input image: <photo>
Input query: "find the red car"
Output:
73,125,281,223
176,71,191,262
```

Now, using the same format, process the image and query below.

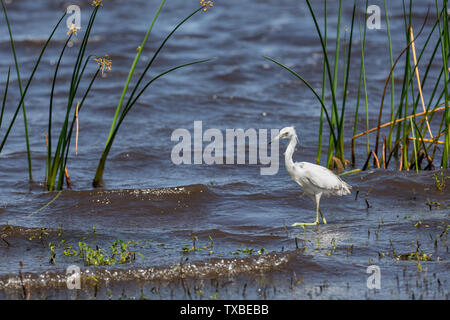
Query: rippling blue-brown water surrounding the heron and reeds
0,0,450,299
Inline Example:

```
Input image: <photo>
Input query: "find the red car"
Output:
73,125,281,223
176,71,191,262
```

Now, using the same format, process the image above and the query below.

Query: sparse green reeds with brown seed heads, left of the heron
0,0,213,191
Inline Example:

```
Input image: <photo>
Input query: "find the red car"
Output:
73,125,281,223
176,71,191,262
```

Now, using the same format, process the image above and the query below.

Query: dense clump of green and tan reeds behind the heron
266,0,450,171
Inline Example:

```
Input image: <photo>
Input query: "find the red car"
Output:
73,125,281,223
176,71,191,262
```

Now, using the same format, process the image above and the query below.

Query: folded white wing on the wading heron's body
294,162,352,196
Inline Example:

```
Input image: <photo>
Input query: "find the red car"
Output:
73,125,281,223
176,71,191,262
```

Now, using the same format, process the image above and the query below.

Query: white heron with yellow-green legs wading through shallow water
271,127,352,227
